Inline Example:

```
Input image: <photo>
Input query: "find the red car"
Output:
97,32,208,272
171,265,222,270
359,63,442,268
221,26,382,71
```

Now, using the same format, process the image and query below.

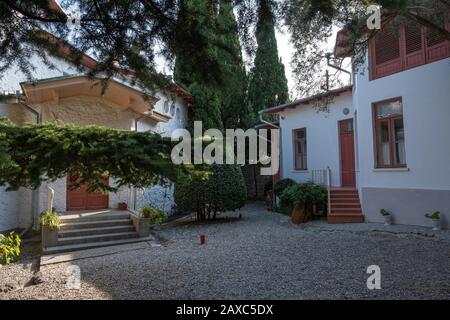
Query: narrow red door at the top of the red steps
339,119,356,187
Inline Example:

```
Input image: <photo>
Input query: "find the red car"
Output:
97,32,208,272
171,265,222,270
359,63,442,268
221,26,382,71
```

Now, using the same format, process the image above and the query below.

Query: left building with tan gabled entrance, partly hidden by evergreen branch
0,36,192,231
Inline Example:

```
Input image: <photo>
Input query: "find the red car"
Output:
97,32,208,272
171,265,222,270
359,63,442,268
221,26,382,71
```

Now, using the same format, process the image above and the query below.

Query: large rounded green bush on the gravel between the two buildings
174,164,247,220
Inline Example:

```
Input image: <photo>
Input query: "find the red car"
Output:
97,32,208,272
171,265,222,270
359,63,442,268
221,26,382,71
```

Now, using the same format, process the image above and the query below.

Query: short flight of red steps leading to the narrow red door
327,188,364,223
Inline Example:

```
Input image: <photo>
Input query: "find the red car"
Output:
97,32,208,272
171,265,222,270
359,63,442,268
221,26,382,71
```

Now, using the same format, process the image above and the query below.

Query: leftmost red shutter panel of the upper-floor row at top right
372,26,402,79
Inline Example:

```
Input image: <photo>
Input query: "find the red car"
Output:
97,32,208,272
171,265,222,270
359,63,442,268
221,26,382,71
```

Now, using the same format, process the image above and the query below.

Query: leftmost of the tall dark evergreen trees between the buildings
174,0,223,129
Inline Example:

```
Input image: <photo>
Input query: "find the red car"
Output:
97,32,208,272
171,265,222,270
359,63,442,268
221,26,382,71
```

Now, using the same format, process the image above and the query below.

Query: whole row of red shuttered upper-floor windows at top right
370,13,450,79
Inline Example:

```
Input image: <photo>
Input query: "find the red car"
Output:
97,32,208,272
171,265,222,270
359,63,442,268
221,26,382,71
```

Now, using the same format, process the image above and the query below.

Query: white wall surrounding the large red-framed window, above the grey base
354,59,450,190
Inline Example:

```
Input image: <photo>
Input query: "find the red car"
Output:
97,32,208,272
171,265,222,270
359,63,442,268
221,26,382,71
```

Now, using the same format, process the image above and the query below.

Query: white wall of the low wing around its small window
280,92,353,186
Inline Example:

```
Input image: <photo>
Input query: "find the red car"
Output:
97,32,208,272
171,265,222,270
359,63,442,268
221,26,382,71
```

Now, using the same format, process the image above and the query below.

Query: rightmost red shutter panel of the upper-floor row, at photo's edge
426,13,449,63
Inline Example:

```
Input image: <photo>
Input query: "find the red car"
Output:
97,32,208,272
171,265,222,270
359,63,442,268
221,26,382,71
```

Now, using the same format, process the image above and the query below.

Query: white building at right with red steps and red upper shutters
263,18,450,227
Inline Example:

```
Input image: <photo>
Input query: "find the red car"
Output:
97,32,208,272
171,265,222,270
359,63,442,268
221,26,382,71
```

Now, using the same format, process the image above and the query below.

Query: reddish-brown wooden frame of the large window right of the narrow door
372,97,407,169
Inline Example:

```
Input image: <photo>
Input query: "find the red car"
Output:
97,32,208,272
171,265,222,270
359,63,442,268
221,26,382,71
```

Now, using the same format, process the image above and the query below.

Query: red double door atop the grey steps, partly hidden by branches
67,178,109,211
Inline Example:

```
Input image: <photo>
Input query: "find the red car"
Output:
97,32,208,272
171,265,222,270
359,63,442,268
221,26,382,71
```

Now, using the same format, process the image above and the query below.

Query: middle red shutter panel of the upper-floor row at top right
404,22,425,69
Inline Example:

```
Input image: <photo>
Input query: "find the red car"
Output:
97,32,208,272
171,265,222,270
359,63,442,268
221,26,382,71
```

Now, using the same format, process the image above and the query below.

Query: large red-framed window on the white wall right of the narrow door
373,98,406,168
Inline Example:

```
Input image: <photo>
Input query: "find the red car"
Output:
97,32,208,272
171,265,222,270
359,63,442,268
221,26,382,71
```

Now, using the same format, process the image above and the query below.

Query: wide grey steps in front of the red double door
43,212,147,254
